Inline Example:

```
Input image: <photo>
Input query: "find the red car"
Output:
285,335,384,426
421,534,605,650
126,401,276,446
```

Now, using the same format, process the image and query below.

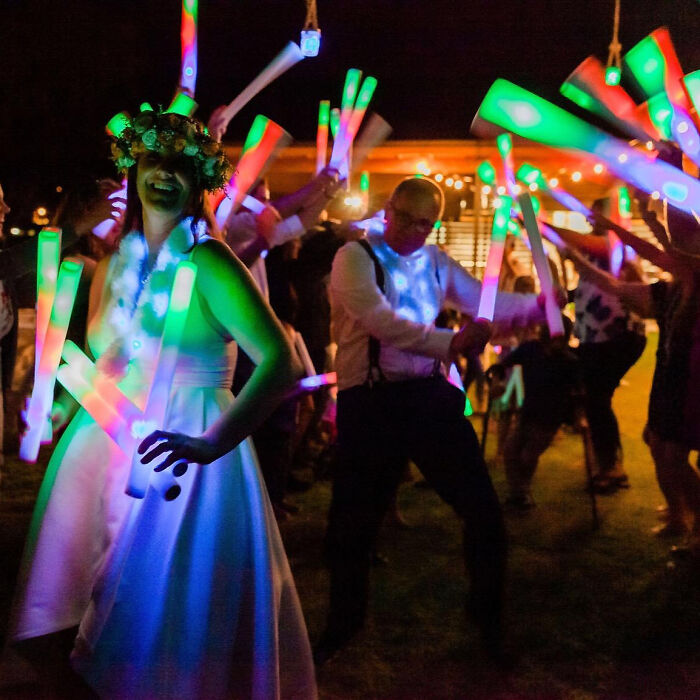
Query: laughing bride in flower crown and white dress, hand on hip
11,105,316,700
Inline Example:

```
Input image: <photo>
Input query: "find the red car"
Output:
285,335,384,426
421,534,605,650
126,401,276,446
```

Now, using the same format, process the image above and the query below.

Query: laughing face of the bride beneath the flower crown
136,153,192,216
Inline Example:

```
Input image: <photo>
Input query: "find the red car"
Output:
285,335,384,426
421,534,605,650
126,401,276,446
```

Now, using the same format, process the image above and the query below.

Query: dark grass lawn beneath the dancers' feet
0,338,700,700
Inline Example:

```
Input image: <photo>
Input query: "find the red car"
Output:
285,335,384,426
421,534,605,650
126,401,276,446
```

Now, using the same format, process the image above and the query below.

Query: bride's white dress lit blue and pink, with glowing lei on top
11,221,316,700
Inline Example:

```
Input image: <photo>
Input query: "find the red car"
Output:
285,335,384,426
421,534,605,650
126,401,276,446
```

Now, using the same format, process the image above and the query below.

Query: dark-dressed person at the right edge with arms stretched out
568,192,700,559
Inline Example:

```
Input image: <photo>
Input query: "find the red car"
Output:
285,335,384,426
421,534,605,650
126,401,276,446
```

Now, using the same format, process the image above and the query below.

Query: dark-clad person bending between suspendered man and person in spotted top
489,316,582,512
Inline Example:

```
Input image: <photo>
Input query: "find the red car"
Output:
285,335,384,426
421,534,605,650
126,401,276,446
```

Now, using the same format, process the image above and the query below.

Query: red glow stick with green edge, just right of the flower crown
211,114,292,226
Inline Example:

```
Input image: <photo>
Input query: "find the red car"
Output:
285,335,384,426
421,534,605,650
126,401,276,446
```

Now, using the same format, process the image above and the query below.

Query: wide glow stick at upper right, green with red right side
623,27,690,111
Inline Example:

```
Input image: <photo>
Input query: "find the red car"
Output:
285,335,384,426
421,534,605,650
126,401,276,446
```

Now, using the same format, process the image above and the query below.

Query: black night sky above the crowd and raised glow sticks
0,0,700,220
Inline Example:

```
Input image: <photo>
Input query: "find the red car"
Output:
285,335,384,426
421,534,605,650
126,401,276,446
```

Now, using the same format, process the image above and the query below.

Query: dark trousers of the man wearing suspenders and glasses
324,377,506,643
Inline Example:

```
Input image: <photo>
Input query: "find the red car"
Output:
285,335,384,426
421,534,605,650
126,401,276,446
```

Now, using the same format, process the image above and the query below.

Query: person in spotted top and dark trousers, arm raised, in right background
551,200,646,494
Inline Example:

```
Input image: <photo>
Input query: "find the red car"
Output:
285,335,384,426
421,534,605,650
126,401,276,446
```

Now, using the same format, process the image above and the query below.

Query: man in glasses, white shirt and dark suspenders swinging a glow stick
314,178,544,665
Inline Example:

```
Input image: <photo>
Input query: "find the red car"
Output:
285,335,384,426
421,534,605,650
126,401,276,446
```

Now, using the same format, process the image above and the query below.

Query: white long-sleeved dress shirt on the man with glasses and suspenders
330,235,544,389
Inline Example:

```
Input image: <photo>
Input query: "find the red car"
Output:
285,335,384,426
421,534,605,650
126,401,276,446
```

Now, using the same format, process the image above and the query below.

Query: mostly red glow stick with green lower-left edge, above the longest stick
560,56,656,141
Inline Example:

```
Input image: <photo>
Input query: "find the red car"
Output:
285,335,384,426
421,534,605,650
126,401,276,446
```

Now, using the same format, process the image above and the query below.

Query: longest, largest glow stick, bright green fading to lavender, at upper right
472,79,700,213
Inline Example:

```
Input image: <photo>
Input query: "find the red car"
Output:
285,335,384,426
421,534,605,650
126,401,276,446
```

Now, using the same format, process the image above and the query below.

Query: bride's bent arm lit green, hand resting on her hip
139,241,302,468
